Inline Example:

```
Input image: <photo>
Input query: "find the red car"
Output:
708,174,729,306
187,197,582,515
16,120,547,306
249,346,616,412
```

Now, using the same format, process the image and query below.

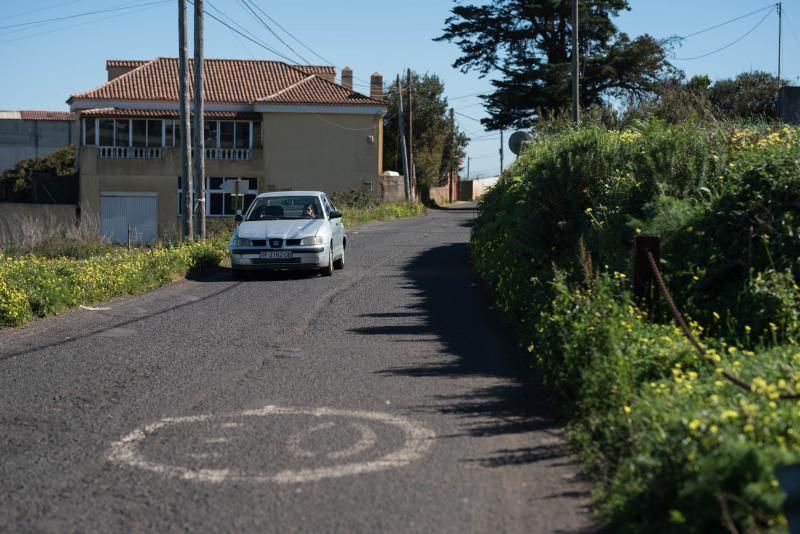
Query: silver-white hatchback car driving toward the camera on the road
230,191,347,279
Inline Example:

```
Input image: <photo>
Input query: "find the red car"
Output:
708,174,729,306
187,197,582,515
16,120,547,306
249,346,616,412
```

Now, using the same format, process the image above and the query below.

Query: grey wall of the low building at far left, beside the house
0,119,75,172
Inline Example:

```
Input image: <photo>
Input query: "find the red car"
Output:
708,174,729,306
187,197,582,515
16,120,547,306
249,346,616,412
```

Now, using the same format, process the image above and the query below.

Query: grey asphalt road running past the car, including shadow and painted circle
0,205,591,533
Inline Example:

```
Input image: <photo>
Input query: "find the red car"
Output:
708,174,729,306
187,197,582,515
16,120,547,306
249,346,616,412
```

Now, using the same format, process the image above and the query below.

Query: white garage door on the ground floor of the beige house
100,193,158,243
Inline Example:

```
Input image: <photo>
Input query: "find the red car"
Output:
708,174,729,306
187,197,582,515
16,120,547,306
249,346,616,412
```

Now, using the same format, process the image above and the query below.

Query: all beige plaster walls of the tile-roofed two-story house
76,113,383,236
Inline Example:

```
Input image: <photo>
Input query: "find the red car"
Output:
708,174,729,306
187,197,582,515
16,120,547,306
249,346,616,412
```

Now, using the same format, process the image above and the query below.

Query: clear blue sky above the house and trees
0,0,800,177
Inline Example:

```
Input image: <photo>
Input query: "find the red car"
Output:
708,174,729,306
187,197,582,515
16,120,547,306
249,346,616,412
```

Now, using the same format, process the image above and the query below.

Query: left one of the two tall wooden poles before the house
179,0,194,241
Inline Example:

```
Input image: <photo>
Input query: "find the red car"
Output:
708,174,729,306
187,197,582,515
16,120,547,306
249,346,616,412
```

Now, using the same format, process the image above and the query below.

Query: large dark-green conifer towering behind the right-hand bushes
436,0,672,129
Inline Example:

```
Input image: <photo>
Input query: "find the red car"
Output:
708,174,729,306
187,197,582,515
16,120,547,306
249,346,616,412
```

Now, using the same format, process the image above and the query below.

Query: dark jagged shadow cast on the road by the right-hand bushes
360,243,584,476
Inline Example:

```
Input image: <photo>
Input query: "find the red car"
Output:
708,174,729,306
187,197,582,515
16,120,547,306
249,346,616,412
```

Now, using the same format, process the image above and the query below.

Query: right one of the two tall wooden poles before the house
194,0,206,239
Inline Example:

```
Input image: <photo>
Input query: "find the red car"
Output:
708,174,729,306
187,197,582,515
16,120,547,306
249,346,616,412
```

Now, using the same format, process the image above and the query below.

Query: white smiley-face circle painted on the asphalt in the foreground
108,406,436,484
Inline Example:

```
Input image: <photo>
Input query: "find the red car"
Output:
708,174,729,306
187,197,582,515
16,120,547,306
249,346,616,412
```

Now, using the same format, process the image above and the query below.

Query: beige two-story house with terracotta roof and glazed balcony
67,58,386,241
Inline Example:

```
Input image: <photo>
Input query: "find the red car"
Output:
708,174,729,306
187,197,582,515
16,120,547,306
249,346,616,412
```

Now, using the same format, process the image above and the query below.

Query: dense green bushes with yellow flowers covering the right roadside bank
471,121,800,532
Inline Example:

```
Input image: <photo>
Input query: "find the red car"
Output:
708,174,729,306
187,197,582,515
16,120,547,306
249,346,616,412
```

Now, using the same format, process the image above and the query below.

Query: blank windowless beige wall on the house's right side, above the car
262,113,383,193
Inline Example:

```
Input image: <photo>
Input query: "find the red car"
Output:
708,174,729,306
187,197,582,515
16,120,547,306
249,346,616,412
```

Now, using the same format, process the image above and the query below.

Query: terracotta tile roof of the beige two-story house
67,58,385,106
